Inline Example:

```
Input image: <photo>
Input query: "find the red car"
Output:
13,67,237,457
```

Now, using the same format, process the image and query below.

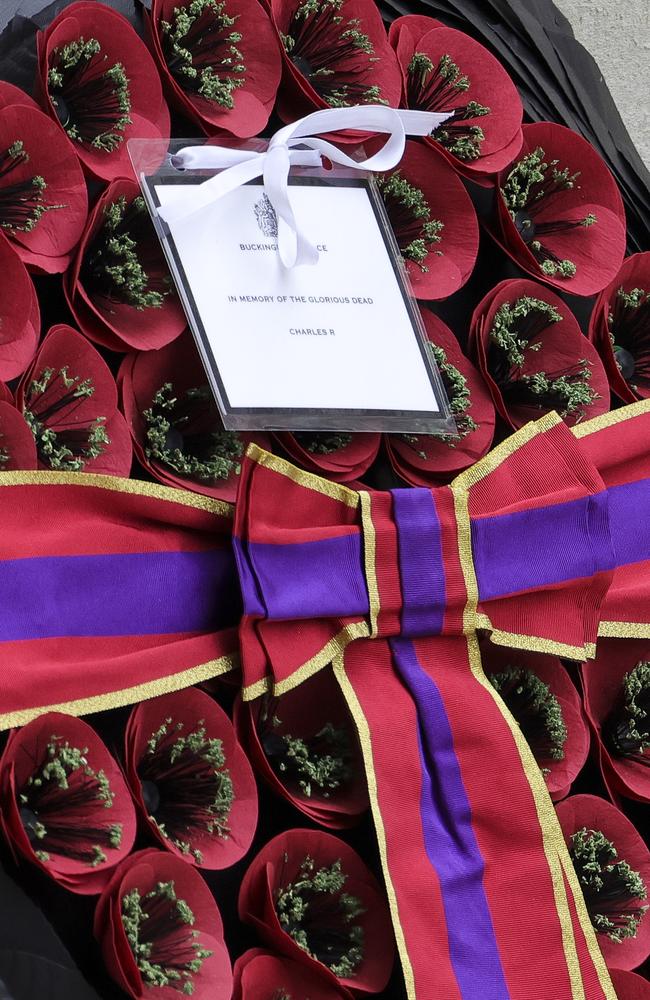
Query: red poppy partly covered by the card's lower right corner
384,309,495,486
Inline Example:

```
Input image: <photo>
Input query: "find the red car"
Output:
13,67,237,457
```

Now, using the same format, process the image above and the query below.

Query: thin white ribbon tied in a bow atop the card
158,104,453,267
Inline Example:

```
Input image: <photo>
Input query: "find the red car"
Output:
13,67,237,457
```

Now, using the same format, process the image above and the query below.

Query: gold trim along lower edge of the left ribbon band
0,656,239,730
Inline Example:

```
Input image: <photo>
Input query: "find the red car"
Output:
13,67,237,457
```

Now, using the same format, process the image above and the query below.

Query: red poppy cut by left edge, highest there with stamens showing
0,83,88,273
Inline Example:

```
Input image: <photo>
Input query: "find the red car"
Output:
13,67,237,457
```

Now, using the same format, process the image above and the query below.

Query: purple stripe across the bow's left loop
233,534,369,621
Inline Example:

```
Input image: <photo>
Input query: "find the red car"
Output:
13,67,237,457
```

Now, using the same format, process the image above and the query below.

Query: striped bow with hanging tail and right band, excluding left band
234,405,650,1000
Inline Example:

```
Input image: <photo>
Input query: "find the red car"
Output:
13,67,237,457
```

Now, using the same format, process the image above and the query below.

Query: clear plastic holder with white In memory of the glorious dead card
128,139,457,437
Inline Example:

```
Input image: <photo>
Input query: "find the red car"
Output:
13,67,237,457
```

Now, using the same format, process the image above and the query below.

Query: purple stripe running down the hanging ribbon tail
390,639,510,1000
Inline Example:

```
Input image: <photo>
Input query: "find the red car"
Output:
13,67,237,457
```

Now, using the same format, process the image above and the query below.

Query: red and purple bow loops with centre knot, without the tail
235,414,616,697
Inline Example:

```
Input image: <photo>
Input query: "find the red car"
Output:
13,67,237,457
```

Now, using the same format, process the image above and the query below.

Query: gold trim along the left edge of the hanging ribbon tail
332,655,417,1000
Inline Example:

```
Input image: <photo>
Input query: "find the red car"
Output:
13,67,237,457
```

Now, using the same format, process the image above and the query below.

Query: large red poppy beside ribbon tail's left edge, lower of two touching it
239,830,395,993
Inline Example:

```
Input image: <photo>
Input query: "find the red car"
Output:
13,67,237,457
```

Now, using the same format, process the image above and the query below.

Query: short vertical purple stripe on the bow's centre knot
391,488,446,637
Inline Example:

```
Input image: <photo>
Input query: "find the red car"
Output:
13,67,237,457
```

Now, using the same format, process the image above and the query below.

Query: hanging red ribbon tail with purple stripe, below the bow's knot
335,636,615,1000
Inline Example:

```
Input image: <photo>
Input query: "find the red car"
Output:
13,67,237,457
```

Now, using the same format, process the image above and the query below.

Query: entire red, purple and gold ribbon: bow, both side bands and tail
0,402,650,1000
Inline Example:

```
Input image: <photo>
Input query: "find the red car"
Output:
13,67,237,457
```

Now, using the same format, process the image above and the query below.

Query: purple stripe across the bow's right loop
472,490,612,601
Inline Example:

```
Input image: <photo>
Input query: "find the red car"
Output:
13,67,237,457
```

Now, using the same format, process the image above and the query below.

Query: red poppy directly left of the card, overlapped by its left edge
64,178,186,351
